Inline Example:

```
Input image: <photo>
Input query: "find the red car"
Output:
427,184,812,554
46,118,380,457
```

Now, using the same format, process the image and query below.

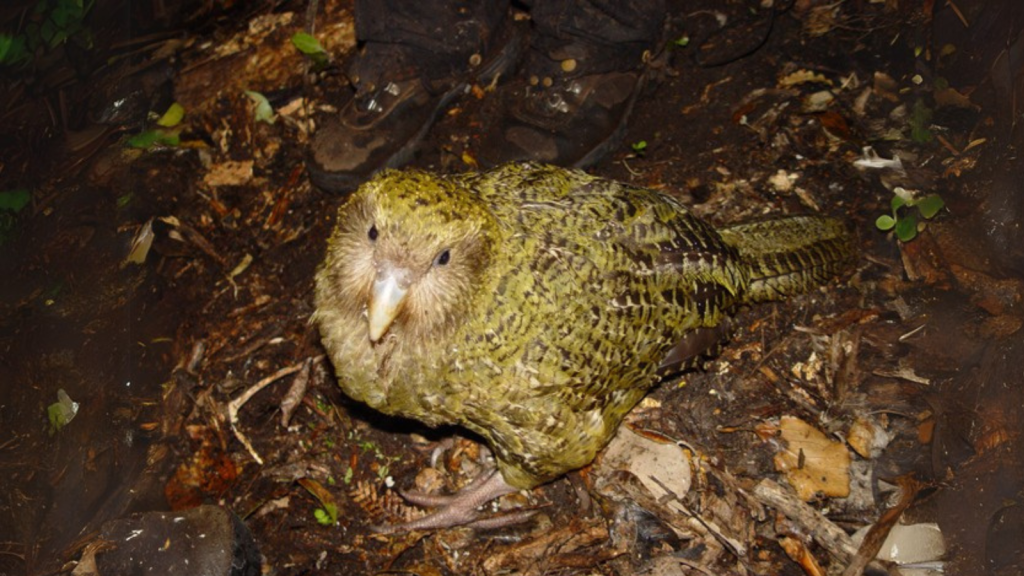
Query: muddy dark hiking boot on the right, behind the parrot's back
476,47,646,168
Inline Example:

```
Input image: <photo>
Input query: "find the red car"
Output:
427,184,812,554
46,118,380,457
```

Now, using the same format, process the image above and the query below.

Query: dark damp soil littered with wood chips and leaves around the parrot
0,0,1024,575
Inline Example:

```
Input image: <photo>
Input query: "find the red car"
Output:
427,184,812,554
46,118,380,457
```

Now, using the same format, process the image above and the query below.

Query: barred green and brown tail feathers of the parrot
719,216,855,302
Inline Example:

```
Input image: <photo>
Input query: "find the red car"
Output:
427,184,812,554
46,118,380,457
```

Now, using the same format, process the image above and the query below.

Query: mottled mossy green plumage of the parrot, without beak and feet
314,164,853,488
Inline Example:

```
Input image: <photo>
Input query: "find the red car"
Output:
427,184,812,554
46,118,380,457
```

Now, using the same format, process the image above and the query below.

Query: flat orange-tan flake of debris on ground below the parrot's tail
774,416,850,501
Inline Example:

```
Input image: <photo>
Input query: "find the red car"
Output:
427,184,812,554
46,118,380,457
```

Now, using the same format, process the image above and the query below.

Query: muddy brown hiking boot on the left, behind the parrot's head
306,17,523,193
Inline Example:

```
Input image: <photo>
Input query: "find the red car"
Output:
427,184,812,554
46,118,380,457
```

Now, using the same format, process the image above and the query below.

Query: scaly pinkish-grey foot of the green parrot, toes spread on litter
374,468,537,534
